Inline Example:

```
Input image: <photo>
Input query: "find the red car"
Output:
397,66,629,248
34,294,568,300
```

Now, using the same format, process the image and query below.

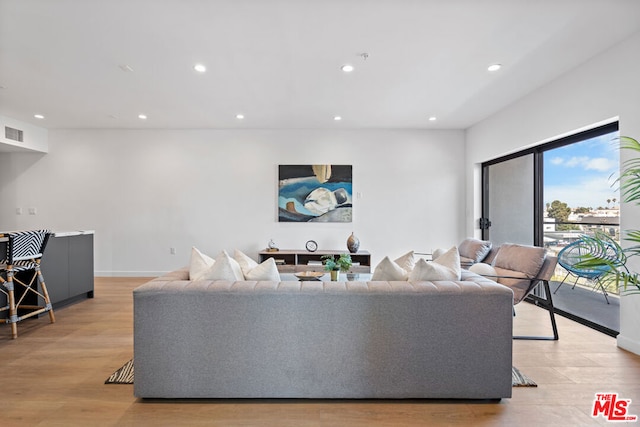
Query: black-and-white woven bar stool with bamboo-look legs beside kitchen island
0,230,56,339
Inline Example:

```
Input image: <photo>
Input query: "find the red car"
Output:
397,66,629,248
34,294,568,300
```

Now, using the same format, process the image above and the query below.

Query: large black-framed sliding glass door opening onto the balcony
480,123,620,335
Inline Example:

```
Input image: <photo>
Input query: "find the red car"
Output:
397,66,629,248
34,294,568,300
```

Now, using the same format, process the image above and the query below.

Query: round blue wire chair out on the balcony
553,239,618,304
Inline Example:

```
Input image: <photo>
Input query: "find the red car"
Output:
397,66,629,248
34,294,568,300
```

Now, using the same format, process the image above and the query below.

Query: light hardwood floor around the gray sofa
0,278,640,427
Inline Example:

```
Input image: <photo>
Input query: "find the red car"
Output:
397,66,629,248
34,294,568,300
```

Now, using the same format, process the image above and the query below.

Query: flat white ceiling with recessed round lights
0,0,640,129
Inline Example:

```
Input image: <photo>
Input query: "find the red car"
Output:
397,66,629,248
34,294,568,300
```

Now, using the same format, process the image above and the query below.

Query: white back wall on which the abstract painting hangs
0,130,464,276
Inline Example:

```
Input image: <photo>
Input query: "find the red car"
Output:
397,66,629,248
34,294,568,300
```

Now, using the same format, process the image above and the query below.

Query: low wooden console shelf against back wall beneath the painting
259,249,371,273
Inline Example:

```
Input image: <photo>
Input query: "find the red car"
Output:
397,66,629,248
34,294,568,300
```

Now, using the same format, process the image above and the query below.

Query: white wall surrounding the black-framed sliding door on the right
465,33,640,354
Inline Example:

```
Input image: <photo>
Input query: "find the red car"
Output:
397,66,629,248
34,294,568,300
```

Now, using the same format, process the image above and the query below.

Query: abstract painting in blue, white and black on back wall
278,165,353,222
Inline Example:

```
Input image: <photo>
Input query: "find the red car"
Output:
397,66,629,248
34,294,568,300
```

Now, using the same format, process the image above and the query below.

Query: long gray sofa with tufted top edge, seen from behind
133,269,513,399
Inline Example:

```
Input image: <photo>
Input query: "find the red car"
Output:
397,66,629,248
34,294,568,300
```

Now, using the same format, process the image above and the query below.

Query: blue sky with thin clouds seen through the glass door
544,132,620,209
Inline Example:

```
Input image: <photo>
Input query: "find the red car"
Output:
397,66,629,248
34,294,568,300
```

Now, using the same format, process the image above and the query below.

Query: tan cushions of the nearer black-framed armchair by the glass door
493,243,545,304
